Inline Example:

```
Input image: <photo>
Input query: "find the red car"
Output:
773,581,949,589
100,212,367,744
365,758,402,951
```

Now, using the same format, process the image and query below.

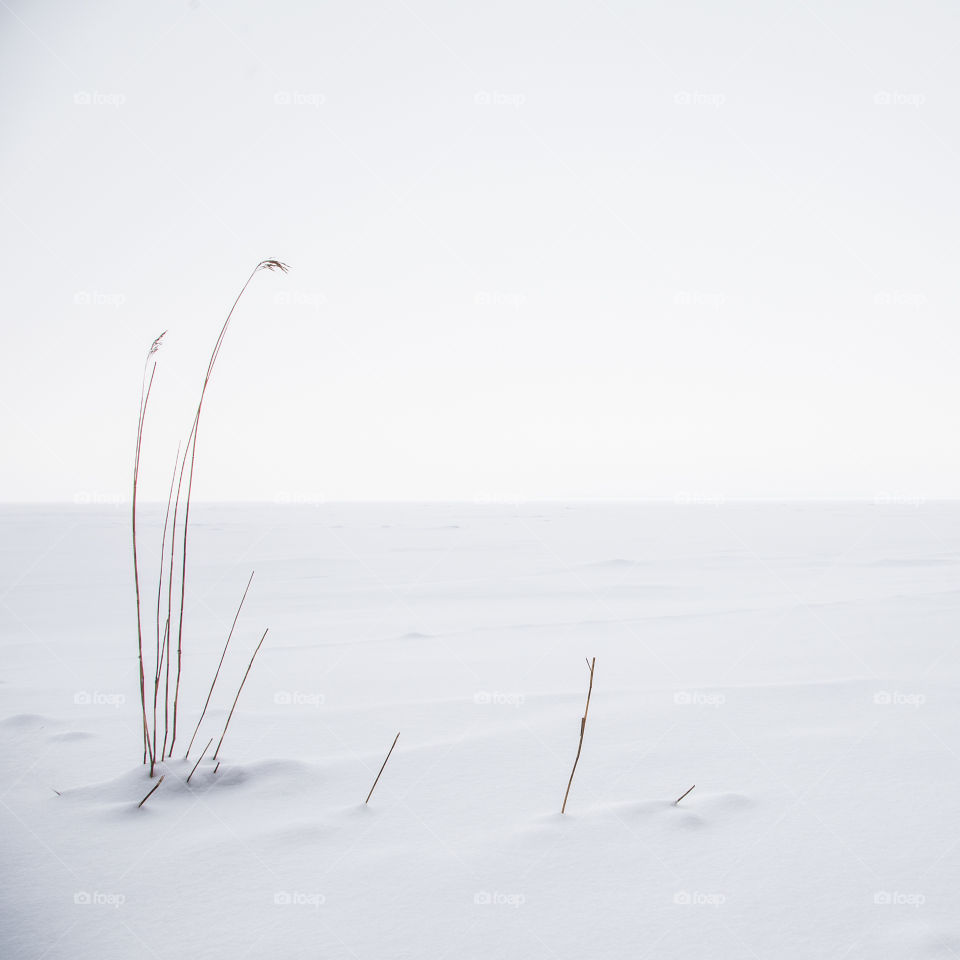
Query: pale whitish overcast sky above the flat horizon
0,0,960,502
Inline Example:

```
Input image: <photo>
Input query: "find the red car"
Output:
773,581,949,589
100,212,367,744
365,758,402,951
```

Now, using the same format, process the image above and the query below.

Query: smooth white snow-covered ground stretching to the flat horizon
0,498,960,960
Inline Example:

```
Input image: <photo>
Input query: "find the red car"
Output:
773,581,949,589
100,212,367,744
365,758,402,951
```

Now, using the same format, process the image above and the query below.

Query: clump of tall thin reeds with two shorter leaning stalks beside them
131,260,290,772
